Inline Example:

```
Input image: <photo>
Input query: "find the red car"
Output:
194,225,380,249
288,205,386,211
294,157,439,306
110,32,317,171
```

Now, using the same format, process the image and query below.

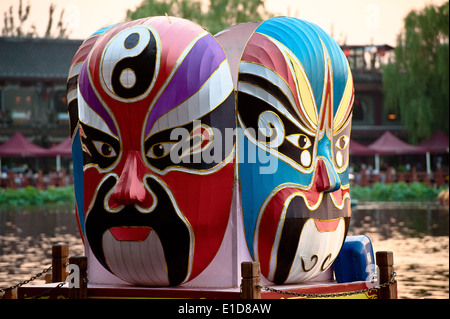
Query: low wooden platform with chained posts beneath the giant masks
8,250,397,300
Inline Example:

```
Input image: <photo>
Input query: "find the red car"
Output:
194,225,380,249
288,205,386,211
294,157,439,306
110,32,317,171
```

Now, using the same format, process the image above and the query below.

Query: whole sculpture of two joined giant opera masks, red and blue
67,17,353,286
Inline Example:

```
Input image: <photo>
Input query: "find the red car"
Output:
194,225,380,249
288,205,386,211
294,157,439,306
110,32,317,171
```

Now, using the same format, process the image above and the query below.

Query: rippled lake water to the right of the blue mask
349,205,449,299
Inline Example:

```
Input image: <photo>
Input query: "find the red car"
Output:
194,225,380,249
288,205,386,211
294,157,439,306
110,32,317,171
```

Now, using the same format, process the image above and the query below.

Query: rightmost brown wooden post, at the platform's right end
376,251,397,299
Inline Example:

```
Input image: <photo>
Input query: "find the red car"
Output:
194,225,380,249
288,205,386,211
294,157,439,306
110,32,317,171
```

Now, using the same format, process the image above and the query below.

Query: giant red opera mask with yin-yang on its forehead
68,17,235,286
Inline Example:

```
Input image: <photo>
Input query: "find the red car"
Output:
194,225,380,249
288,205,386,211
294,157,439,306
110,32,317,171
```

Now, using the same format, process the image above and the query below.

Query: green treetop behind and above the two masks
127,0,272,34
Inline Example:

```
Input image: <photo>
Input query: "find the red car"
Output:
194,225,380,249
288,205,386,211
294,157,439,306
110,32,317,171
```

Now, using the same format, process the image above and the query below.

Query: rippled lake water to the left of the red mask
0,207,84,296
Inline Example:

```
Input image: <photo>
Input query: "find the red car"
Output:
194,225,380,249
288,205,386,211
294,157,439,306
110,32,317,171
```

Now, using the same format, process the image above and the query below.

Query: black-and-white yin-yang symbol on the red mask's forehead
100,25,161,102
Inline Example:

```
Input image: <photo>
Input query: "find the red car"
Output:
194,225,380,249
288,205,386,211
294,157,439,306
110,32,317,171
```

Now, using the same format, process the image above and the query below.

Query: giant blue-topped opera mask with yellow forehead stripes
237,17,353,284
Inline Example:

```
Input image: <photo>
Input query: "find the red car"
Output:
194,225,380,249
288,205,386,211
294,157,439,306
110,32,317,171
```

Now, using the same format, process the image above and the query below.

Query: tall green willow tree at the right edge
383,2,449,143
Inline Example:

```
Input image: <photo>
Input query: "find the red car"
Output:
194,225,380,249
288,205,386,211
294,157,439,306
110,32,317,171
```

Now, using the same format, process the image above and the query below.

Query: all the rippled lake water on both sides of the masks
0,204,449,299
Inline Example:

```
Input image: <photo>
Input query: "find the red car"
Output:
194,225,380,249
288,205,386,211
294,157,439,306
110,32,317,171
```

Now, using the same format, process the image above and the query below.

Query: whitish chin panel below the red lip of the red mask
103,230,169,286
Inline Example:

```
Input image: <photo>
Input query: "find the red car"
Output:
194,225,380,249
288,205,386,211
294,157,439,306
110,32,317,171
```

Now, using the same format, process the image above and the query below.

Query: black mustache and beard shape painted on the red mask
86,176,191,286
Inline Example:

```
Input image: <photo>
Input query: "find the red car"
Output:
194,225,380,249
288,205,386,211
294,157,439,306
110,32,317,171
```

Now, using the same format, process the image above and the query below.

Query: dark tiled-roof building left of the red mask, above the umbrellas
0,37,82,146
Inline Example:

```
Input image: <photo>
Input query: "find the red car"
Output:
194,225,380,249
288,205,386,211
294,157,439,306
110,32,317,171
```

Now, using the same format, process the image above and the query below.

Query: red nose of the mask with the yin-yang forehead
112,151,147,205
